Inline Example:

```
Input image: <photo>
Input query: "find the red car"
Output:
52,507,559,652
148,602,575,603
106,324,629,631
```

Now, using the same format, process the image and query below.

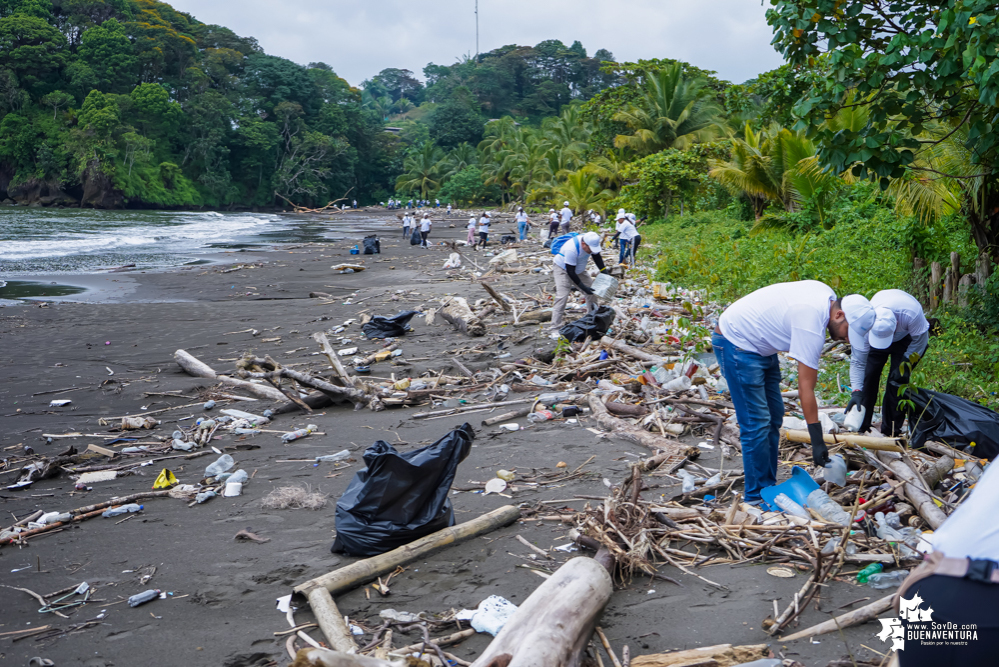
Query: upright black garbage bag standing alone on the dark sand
331,423,475,556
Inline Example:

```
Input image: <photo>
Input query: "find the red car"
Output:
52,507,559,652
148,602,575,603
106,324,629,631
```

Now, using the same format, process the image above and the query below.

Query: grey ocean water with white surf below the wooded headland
0,206,384,279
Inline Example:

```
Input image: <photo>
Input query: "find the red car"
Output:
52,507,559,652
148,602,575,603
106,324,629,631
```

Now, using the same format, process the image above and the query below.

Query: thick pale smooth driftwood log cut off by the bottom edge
472,557,614,667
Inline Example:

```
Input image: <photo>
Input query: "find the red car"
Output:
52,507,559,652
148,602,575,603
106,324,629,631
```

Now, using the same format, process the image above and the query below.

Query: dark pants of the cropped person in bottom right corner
898,574,999,667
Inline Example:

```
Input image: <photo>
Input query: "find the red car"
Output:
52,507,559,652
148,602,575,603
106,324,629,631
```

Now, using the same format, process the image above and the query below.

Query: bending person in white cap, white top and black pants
846,289,930,438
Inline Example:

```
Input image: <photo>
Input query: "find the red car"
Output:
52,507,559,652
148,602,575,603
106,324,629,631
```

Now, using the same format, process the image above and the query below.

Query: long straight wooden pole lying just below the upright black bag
294,505,520,595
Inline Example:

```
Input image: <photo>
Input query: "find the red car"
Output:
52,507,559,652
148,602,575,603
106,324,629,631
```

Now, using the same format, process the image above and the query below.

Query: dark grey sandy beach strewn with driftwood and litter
0,212,883,667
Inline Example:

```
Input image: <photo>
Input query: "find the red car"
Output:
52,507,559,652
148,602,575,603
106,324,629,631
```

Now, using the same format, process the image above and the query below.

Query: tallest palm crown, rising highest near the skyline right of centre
614,63,728,155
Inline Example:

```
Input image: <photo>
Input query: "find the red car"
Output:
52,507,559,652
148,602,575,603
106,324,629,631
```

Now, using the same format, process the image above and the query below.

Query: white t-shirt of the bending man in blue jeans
718,280,836,370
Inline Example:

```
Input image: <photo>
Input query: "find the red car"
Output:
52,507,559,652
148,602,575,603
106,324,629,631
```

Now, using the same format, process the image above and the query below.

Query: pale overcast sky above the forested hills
168,0,782,85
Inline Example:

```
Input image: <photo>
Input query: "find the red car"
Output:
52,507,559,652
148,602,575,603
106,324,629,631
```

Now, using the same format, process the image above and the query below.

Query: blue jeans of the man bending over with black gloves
711,332,784,502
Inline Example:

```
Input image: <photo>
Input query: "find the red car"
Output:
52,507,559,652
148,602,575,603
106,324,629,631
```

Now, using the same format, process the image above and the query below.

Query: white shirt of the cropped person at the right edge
931,463,999,560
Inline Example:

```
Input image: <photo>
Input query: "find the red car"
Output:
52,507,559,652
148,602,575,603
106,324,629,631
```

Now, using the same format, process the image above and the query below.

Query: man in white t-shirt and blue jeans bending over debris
711,280,875,504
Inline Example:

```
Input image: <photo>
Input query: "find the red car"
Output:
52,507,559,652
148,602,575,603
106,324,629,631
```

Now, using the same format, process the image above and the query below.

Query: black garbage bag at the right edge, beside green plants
903,388,999,461
